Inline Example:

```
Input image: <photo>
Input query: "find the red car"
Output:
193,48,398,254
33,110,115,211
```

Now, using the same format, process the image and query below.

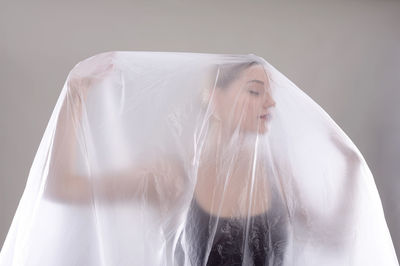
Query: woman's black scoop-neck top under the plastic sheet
185,188,287,266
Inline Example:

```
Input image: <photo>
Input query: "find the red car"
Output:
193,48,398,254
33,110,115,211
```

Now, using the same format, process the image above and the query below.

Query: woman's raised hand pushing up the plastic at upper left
67,51,116,105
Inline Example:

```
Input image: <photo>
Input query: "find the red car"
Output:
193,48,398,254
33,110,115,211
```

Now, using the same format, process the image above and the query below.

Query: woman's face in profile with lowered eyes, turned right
214,65,275,134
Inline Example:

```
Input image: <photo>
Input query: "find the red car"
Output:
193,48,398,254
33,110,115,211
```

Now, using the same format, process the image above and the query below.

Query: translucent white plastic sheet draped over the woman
0,51,399,266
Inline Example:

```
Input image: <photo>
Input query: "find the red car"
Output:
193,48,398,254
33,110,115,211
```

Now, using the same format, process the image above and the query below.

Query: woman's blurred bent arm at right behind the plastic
278,132,362,241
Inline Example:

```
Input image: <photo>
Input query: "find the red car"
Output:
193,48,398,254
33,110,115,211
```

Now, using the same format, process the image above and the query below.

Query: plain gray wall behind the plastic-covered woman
0,0,400,254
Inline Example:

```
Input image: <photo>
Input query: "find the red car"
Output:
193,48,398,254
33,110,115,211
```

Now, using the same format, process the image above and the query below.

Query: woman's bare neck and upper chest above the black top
195,123,267,213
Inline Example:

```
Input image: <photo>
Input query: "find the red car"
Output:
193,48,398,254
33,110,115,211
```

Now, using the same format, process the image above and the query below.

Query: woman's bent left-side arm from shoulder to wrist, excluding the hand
45,91,184,204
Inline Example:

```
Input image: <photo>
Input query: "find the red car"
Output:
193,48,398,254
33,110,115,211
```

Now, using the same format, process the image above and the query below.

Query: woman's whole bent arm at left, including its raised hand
44,54,184,208
